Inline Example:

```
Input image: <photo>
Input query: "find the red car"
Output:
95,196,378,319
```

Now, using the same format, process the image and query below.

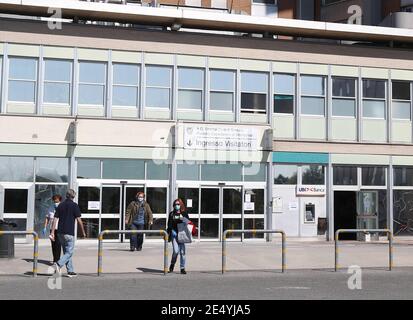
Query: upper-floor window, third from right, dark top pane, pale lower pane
332,77,356,118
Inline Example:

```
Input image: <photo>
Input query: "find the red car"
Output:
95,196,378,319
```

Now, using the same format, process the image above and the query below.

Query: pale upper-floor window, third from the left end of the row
79,61,106,106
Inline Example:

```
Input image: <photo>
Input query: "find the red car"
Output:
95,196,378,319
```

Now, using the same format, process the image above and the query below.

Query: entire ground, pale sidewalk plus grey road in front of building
0,239,413,300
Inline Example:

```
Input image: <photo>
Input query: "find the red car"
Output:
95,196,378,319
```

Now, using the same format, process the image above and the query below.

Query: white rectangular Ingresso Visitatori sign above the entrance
184,125,258,151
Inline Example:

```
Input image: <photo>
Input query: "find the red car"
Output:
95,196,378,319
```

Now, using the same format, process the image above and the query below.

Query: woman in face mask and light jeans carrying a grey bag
167,199,190,274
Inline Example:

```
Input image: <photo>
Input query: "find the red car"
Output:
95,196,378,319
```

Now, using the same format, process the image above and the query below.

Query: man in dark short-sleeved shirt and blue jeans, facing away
50,189,86,278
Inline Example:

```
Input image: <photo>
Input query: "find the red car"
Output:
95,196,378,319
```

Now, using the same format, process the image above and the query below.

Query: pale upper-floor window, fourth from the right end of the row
301,76,326,116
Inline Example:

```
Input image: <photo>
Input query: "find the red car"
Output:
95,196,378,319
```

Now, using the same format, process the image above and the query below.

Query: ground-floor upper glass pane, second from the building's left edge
36,158,69,183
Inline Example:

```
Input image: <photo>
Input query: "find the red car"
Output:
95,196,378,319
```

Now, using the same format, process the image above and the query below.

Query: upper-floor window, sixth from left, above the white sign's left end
178,68,204,110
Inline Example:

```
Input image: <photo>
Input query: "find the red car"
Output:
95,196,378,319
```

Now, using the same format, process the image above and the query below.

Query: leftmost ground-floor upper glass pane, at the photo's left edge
0,157,34,182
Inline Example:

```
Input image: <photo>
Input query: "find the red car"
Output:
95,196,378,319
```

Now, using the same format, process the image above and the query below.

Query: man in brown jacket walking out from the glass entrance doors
125,192,153,251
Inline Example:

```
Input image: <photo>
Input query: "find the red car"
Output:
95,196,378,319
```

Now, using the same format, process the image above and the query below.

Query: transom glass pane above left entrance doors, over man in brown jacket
102,160,145,180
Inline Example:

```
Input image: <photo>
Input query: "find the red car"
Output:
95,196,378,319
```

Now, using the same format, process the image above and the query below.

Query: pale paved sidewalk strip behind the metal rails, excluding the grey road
0,239,413,281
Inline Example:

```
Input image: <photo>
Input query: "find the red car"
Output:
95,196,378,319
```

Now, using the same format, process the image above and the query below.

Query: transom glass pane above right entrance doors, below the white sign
201,163,242,181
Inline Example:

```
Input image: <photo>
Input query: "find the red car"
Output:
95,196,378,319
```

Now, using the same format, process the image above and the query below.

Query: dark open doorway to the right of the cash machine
334,191,357,240
